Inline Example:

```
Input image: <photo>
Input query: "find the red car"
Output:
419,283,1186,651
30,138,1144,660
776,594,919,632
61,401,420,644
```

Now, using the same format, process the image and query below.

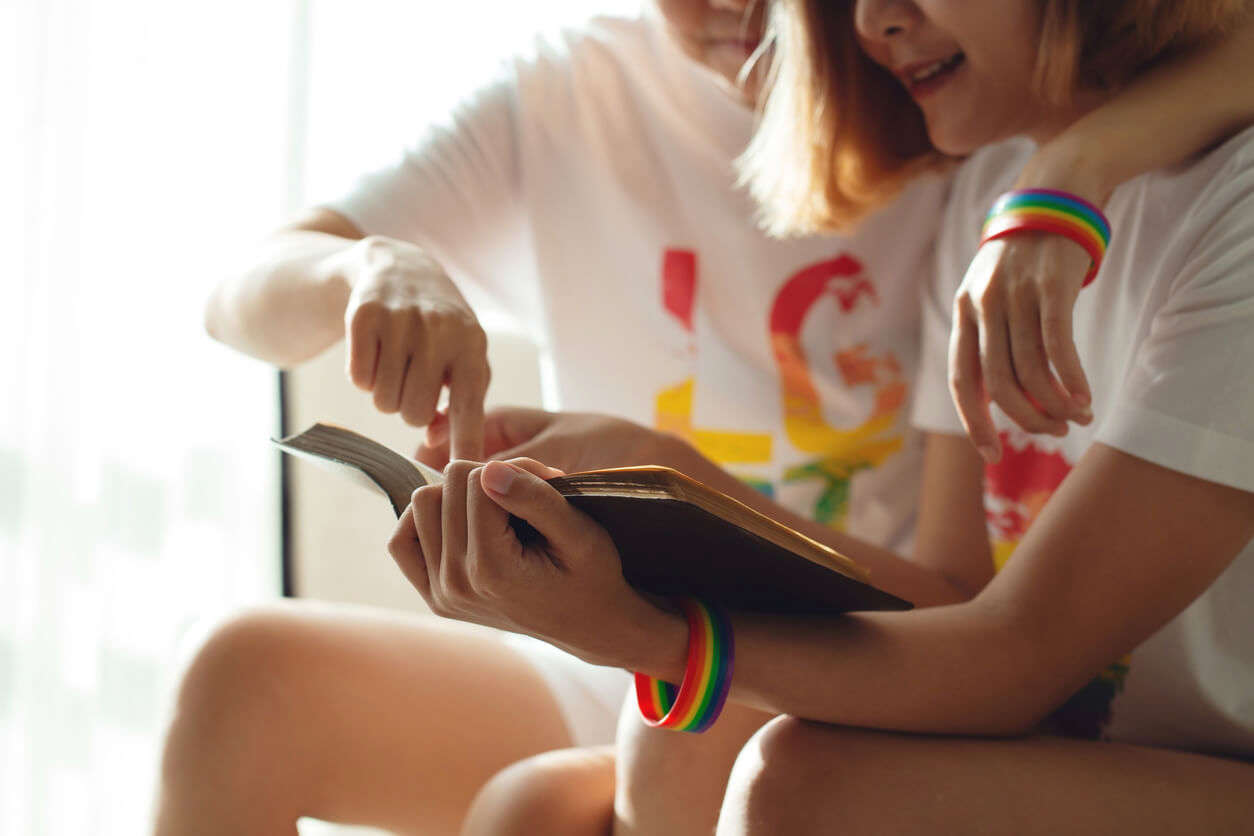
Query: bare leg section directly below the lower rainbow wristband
613,696,771,836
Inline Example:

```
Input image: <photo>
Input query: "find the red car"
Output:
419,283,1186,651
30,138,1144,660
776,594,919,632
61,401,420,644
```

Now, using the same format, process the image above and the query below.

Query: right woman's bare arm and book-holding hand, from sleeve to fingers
389,428,1254,734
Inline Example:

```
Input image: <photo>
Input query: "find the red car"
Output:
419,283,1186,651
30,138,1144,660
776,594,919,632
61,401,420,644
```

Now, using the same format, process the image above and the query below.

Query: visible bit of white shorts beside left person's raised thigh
505,633,632,746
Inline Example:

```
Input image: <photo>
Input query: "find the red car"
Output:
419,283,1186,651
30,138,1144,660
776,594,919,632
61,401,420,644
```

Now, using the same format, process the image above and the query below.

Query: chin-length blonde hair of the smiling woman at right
737,0,1254,237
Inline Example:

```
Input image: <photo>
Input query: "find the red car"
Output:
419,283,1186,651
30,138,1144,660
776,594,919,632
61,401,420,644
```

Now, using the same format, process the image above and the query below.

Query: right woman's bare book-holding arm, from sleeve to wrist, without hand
636,439,1254,734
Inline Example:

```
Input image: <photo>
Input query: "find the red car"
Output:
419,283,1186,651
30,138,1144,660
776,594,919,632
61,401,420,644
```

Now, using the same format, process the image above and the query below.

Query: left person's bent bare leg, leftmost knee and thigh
155,604,571,836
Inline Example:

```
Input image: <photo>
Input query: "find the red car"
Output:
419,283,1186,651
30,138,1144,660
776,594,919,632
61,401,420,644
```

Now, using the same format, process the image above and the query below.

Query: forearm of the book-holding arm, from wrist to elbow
632,600,1048,734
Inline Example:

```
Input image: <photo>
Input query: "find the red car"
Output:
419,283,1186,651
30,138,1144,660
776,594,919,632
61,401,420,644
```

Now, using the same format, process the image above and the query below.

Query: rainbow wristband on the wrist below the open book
636,598,736,732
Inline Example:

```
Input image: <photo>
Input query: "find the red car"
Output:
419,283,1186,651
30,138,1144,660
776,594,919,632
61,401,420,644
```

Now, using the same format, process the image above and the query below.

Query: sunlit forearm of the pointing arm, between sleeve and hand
204,229,360,366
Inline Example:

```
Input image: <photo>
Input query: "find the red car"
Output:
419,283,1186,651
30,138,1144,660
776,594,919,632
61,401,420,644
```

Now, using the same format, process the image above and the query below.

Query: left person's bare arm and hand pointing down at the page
204,209,489,459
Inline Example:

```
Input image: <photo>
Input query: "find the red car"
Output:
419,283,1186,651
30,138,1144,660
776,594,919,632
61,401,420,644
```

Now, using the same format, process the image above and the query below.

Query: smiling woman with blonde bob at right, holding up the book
381,0,1254,835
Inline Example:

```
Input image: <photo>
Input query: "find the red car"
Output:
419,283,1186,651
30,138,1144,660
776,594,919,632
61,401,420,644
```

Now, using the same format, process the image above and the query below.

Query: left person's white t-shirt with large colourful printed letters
329,18,946,548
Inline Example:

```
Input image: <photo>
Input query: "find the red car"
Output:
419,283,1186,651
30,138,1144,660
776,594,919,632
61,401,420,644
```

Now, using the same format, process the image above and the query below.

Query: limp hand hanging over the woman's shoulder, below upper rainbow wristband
949,233,1092,461
